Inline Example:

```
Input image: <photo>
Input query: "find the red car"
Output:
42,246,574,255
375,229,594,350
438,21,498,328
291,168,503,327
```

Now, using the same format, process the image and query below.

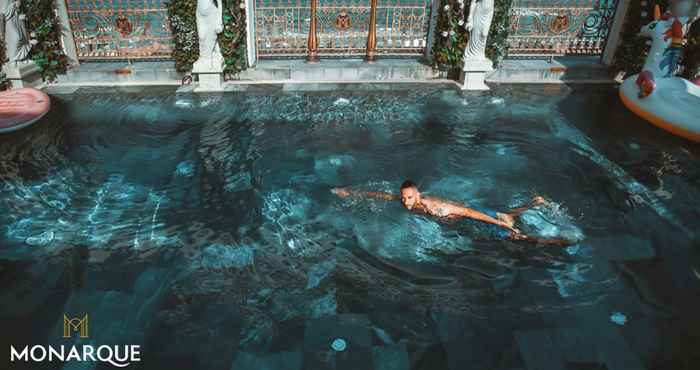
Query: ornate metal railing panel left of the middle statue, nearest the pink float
65,0,173,60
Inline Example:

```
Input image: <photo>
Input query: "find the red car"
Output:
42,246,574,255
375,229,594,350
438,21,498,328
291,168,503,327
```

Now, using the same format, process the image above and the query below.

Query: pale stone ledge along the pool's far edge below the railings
49,57,614,92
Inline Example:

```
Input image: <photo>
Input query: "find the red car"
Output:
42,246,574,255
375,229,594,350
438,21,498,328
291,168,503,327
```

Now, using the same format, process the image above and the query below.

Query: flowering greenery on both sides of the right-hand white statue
431,0,512,69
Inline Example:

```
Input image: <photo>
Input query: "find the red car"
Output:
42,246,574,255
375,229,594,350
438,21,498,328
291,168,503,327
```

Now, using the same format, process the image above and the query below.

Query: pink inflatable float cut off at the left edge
0,88,51,134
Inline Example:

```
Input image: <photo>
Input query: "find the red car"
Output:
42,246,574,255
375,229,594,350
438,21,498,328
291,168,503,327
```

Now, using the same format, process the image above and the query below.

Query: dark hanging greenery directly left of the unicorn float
613,0,668,75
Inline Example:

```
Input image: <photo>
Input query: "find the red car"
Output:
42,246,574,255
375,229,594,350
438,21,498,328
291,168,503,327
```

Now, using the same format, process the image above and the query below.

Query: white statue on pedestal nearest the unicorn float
464,0,494,61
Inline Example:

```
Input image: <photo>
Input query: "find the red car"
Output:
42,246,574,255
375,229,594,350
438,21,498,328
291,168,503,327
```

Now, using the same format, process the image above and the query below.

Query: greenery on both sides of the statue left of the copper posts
167,0,247,74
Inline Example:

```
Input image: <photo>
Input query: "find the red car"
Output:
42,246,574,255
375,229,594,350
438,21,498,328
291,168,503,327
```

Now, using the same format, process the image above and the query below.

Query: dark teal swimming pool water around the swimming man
0,85,700,370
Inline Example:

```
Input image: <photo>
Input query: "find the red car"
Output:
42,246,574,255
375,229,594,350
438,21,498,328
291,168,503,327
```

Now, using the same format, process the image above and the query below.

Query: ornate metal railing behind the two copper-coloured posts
255,0,430,58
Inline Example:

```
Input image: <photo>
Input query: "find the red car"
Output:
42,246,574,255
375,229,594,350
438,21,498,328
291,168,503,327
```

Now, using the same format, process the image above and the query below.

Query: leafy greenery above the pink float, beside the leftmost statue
19,0,68,81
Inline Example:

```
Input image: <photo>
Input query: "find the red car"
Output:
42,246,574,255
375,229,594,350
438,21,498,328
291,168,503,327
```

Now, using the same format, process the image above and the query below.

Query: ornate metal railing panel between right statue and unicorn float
508,0,618,57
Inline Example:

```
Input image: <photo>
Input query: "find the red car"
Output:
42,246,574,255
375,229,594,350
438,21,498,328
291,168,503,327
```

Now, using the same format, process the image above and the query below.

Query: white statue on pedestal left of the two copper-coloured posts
195,0,224,70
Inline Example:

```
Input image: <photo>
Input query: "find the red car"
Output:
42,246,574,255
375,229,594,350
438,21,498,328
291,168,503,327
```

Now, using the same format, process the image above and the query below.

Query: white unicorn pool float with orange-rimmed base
620,0,700,142
